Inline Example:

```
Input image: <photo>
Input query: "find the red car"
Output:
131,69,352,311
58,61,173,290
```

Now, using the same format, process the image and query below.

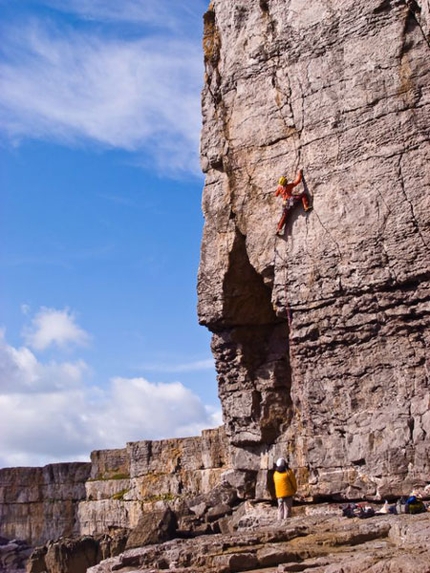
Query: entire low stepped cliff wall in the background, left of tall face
0,428,231,546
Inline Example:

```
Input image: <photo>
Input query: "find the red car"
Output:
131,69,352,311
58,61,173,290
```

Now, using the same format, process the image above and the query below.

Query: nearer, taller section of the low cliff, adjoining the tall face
77,428,231,534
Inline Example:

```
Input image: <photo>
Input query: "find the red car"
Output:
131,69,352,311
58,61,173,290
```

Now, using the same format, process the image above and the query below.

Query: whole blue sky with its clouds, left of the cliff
0,0,221,467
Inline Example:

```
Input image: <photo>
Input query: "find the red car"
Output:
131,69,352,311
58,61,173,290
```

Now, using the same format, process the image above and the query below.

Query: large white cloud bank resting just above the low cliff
0,328,221,467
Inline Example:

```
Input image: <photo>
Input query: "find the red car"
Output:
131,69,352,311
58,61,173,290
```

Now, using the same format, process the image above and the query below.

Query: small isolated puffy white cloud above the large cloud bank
23,308,90,350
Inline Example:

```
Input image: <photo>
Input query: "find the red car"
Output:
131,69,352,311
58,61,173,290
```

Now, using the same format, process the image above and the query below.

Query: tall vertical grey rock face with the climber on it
198,0,430,497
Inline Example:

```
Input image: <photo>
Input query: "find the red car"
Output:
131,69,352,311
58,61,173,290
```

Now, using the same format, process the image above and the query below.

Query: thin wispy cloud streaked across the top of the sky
0,0,202,172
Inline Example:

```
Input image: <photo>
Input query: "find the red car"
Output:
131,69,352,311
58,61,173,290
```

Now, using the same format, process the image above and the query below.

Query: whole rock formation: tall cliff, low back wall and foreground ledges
0,0,430,573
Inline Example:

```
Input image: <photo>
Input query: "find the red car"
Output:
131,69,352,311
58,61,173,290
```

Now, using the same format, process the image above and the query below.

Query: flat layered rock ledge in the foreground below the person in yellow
88,504,430,573
